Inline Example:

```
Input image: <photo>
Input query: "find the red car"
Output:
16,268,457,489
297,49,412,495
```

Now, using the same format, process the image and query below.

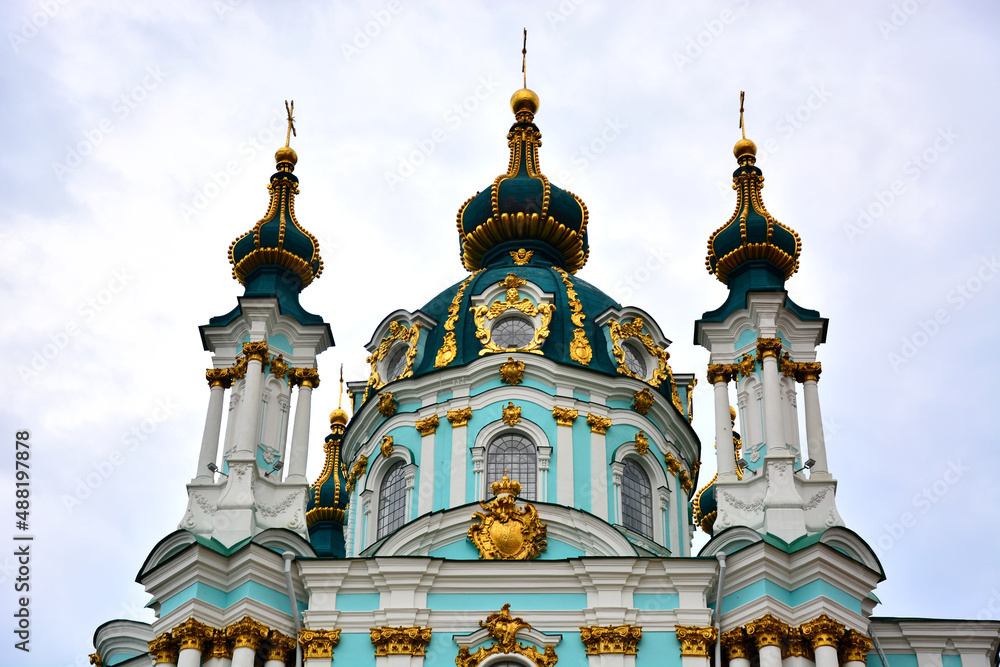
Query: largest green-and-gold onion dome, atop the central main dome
458,88,590,273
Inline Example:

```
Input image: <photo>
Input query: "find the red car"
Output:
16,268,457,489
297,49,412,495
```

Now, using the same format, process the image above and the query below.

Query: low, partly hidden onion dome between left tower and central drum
306,408,349,558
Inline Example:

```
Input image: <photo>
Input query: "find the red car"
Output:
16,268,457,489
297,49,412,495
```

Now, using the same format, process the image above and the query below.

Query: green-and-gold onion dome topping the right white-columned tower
705,134,802,287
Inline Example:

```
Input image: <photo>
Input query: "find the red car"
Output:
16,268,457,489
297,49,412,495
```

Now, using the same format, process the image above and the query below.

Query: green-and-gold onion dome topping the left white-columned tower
229,145,323,291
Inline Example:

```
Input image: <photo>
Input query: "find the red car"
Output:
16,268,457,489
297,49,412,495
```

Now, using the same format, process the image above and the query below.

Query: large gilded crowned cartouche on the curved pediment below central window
468,475,548,560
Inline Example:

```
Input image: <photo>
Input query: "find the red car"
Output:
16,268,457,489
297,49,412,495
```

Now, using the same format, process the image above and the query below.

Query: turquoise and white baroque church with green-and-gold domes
91,77,1000,667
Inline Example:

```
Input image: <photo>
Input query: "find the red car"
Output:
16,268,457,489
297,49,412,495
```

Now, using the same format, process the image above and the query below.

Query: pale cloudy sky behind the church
0,0,1000,666
